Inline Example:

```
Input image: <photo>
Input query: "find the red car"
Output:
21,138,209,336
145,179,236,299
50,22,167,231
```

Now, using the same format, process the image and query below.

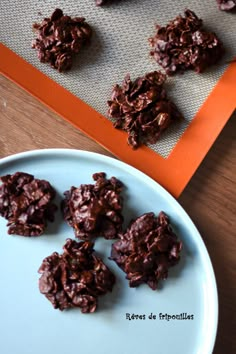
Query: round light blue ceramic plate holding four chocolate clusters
0,149,218,354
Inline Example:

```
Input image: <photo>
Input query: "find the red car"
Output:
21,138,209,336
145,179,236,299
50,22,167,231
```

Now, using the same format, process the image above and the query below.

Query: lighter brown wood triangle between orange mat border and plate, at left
0,75,112,157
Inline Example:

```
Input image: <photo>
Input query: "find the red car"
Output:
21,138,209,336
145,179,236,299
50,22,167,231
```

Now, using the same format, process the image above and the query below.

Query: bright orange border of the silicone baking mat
0,43,236,198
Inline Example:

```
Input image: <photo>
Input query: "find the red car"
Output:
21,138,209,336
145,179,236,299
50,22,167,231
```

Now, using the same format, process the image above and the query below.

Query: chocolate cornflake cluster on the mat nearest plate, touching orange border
108,71,182,149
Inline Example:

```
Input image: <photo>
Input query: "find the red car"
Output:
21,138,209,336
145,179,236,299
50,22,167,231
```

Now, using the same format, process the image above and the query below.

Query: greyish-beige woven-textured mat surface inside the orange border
0,0,236,158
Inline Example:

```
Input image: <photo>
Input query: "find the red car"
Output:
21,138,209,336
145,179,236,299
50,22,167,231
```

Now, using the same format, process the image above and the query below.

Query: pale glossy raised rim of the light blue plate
0,148,219,354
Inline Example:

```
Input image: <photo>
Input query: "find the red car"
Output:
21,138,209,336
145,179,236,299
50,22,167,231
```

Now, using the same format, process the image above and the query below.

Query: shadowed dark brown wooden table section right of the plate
179,110,236,354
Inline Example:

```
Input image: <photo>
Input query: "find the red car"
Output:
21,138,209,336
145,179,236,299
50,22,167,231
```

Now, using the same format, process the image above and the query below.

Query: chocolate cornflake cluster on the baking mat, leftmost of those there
32,9,92,72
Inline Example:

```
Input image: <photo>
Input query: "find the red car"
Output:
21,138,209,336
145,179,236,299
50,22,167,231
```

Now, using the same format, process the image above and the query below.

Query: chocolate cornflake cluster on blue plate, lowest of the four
38,239,115,313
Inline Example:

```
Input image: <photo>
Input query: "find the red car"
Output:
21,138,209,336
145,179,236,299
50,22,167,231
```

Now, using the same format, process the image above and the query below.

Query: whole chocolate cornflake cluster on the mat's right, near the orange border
149,10,224,75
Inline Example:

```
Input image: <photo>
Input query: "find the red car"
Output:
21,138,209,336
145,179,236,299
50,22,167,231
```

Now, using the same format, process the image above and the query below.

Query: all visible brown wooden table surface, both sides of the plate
0,76,236,354
